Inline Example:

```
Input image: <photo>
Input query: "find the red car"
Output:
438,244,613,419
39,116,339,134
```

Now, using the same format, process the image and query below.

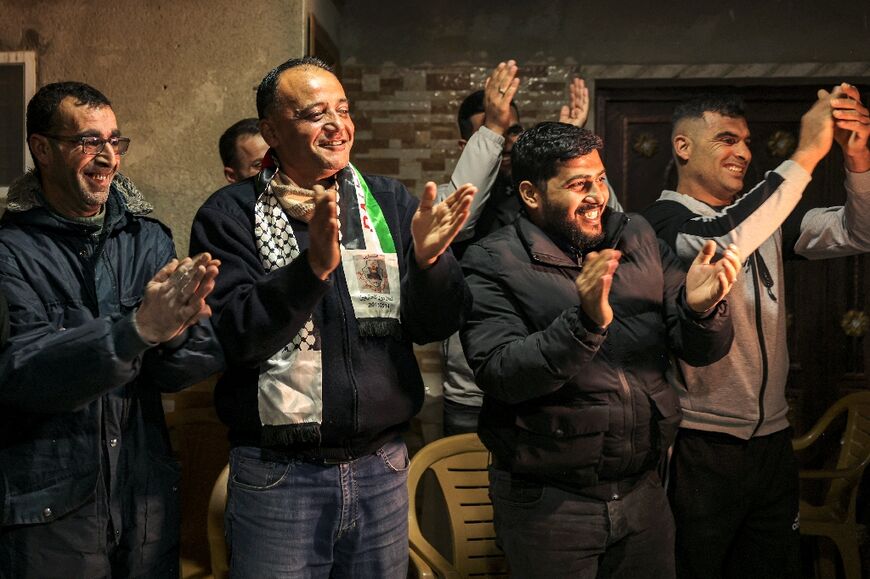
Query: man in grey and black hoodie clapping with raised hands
644,84,870,579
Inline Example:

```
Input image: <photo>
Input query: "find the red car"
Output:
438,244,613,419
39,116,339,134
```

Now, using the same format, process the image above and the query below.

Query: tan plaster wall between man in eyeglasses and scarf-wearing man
0,0,306,255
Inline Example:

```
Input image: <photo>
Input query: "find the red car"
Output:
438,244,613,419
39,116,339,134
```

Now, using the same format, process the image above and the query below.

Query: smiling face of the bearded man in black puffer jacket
520,150,610,250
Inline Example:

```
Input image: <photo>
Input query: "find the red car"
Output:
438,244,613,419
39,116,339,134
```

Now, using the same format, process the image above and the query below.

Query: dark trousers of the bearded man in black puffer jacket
489,467,675,579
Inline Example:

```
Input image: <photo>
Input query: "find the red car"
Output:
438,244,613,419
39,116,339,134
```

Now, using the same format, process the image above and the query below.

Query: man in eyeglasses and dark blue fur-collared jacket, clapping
0,82,223,577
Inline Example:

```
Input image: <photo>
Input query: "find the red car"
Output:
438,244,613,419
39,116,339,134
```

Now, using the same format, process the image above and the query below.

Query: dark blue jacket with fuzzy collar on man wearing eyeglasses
0,175,223,572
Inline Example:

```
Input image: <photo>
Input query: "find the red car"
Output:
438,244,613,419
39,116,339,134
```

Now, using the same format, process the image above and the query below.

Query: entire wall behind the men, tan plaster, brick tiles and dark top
8,0,870,254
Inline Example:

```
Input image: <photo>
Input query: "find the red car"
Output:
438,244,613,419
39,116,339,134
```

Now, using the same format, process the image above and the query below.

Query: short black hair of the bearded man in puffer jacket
511,122,603,193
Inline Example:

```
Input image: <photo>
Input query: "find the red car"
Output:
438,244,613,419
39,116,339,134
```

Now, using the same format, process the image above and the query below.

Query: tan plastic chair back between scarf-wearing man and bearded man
408,434,508,577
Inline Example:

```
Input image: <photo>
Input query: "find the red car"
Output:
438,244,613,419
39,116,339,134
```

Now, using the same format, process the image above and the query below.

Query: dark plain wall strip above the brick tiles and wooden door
342,0,870,66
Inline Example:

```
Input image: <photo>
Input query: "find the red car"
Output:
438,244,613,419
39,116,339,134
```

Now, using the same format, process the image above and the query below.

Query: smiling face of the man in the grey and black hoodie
673,111,752,206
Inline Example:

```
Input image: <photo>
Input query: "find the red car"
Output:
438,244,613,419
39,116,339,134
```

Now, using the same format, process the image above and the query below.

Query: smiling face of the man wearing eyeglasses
30,97,121,217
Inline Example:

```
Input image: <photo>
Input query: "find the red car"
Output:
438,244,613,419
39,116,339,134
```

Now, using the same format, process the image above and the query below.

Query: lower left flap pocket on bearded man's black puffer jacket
513,404,610,472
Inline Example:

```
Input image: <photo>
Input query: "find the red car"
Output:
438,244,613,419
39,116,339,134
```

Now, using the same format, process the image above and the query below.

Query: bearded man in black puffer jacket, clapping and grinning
461,123,740,578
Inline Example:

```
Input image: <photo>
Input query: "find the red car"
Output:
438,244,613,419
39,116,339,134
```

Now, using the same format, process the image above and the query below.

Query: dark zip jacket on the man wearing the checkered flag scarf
190,172,470,456
